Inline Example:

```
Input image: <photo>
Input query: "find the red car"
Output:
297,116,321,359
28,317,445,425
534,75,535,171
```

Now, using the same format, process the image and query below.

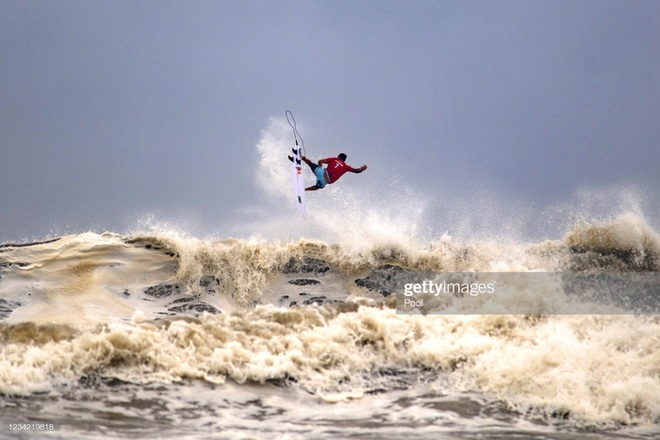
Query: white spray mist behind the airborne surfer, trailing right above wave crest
250,117,658,251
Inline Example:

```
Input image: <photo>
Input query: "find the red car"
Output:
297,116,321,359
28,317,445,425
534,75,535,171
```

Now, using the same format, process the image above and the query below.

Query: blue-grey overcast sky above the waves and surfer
0,0,660,241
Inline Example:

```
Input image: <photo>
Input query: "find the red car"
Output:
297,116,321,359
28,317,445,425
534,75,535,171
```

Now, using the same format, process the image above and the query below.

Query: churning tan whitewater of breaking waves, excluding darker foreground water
0,212,660,432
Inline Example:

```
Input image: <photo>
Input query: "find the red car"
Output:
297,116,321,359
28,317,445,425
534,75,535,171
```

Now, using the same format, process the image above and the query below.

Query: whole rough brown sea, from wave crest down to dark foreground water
0,216,660,439
